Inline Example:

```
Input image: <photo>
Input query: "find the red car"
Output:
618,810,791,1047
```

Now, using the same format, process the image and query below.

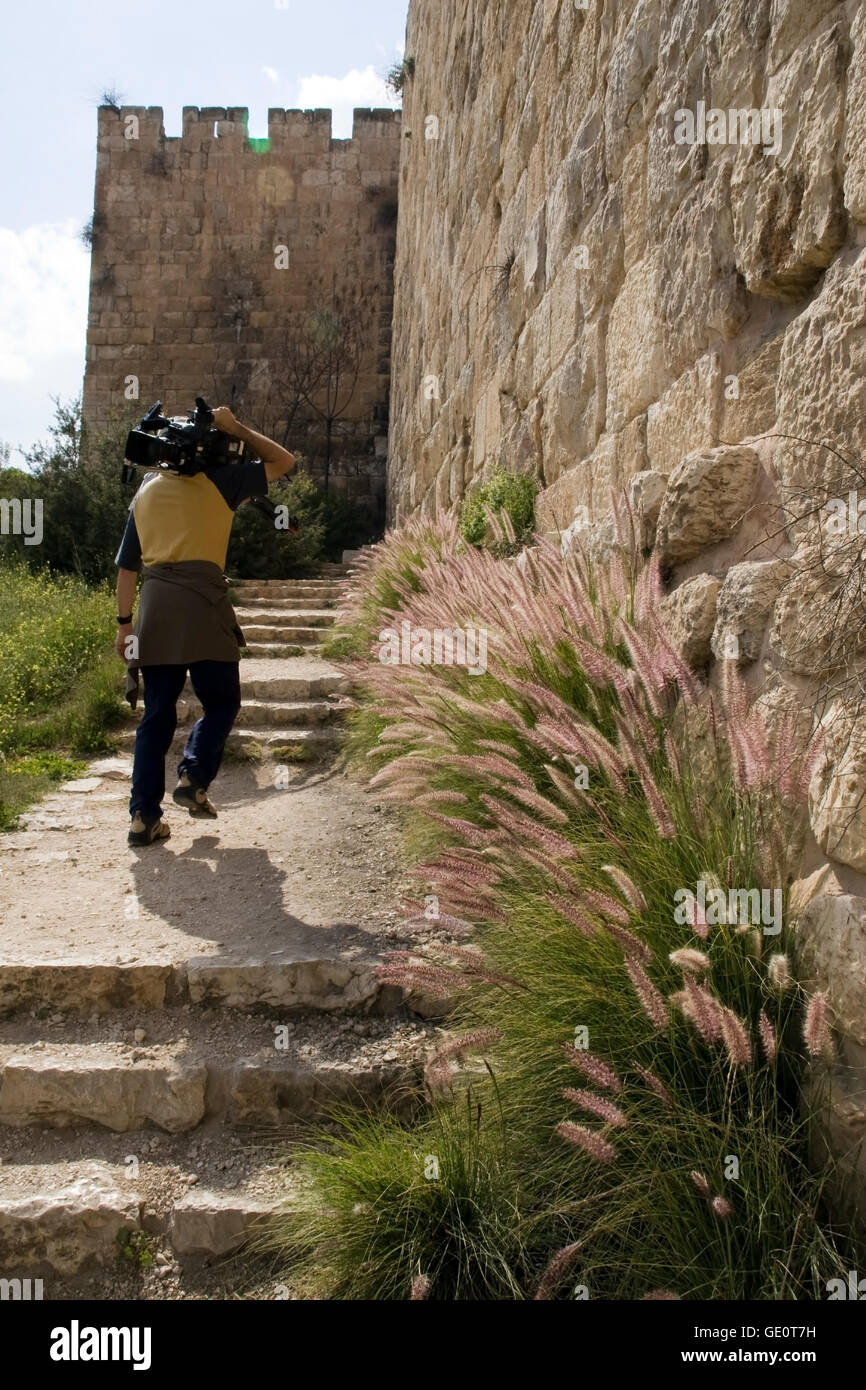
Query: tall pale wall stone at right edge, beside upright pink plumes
809,701,866,872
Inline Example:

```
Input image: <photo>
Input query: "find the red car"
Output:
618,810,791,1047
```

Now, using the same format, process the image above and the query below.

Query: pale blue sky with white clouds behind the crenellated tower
0,0,407,463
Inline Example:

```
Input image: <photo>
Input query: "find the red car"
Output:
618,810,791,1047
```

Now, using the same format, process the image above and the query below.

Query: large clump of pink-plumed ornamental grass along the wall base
272,512,851,1300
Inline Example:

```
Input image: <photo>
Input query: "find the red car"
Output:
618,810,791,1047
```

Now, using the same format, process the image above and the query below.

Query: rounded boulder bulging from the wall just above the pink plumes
656,445,759,566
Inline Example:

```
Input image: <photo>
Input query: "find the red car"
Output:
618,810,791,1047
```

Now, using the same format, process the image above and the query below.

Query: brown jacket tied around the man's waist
126,560,246,709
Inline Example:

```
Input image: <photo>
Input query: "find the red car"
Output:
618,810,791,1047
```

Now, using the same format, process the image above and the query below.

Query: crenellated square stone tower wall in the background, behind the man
83,107,400,509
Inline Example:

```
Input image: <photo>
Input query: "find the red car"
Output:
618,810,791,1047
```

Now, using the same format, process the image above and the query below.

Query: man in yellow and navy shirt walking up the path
115,406,295,847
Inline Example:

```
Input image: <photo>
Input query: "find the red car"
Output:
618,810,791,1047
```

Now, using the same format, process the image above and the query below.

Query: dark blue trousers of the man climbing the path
129,662,240,820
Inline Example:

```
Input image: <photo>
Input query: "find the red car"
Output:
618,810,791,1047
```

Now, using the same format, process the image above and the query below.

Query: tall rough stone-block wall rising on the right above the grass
389,0,866,1209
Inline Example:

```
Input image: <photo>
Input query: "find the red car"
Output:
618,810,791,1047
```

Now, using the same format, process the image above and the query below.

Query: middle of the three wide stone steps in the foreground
0,1011,425,1134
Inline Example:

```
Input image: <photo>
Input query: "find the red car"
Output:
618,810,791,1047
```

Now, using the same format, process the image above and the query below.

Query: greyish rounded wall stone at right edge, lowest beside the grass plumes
794,892,866,1047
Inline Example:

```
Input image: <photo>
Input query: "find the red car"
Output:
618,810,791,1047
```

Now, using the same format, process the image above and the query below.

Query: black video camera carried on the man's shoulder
121,396,299,532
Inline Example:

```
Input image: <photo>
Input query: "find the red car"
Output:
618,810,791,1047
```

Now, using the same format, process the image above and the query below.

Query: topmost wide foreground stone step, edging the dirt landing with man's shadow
0,948,400,1033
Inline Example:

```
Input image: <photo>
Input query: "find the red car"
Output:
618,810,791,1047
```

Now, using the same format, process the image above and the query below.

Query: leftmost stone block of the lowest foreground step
0,1163,140,1273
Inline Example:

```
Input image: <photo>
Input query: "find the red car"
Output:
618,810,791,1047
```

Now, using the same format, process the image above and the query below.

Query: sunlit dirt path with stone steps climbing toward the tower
0,569,436,1300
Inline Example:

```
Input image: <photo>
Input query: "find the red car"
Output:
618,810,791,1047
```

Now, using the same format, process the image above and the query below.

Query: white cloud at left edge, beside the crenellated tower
0,218,90,381
